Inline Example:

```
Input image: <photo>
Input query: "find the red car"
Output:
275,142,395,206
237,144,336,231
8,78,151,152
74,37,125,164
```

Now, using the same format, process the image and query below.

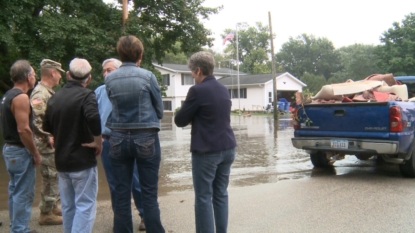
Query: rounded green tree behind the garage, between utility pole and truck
276,34,340,79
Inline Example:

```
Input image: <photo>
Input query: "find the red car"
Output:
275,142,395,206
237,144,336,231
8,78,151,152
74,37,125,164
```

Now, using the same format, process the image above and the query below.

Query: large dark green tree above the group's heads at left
0,0,221,92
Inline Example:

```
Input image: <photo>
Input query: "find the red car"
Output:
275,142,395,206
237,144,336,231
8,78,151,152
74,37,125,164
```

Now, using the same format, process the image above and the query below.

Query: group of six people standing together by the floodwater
0,35,236,233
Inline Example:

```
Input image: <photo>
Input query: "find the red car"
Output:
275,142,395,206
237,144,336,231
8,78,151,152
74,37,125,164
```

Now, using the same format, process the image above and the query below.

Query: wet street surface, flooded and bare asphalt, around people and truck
0,116,415,233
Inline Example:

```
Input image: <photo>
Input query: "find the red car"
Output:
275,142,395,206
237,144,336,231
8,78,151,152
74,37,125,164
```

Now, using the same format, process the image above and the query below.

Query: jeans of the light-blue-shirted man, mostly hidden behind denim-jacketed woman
101,139,144,217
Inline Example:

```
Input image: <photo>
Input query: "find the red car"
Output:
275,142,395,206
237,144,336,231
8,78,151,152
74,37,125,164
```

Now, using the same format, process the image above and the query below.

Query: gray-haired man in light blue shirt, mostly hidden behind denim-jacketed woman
95,58,146,231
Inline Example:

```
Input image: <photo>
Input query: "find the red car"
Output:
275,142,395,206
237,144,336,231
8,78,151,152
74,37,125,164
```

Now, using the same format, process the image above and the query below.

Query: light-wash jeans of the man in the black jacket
58,167,98,233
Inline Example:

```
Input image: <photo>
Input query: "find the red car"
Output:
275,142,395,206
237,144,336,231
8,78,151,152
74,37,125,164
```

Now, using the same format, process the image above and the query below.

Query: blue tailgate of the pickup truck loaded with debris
296,102,390,139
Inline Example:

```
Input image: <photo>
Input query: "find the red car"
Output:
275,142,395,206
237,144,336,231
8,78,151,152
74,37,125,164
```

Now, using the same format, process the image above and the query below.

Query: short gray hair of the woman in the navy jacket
187,51,215,76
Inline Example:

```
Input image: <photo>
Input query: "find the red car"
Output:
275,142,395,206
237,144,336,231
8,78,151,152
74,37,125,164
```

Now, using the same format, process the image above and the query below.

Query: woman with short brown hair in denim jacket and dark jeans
105,35,165,233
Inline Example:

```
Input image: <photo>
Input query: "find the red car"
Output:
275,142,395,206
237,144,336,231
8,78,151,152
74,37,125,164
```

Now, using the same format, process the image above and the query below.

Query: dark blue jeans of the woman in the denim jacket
110,130,164,233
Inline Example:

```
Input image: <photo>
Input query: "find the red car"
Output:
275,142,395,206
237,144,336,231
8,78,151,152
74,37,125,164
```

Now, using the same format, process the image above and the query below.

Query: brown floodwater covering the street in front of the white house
0,115,392,210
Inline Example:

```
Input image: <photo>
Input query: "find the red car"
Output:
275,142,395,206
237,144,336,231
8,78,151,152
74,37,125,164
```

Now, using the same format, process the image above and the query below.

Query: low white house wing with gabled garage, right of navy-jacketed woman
218,72,307,111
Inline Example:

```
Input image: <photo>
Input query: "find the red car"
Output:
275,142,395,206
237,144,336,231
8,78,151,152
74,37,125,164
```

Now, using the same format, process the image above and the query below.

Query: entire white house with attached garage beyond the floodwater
153,63,307,111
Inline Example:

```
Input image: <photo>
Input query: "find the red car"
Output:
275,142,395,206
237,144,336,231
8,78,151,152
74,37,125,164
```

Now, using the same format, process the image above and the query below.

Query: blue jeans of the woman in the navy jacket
192,148,235,233
